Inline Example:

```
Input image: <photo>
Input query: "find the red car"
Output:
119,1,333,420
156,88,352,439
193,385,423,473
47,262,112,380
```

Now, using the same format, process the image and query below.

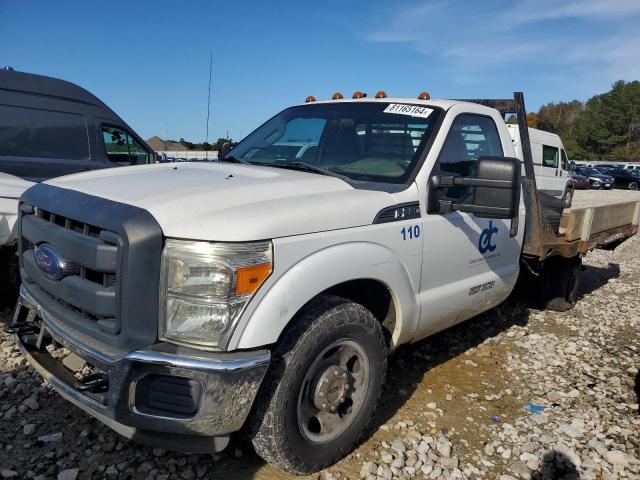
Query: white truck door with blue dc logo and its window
417,112,524,338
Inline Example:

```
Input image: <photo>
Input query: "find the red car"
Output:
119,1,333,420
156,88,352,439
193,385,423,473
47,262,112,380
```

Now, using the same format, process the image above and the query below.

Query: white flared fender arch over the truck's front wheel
229,242,420,350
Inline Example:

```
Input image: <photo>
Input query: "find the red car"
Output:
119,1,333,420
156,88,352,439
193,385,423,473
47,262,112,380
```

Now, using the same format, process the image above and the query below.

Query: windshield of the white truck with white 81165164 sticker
228,102,441,183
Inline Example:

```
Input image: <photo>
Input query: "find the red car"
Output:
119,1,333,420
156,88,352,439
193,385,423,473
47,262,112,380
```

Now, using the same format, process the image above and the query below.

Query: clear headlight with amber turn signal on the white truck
159,240,272,349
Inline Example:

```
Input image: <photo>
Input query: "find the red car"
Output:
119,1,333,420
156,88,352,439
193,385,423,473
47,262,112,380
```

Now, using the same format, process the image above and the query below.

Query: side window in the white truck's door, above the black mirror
437,114,504,199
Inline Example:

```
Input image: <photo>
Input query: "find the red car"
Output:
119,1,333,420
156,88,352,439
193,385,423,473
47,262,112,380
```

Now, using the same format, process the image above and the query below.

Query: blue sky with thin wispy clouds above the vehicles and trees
0,0,640,141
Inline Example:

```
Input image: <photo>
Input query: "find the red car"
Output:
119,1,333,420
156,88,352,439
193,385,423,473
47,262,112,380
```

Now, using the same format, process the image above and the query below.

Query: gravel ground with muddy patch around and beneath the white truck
0,191,640,480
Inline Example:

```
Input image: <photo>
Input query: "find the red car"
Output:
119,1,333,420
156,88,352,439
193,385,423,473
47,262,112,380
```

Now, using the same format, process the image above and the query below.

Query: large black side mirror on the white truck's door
429,157,521,219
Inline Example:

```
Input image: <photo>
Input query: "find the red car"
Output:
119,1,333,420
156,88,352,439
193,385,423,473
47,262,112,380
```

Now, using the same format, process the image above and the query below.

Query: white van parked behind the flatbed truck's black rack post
507,124,573,206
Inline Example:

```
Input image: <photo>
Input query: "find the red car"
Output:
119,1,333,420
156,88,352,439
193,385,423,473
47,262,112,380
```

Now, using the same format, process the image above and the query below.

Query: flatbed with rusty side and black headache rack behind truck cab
461,92,640,261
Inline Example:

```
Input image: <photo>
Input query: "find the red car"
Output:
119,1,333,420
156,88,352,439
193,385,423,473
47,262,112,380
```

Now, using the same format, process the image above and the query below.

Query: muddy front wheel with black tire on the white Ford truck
250,296,387,475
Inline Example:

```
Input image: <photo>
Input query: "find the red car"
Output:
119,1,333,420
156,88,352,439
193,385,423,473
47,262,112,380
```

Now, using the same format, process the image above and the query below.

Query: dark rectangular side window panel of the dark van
0,105,89,160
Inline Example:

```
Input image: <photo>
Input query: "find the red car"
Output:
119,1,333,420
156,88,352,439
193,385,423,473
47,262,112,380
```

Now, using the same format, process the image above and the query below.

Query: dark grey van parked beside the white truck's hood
0,66,155,181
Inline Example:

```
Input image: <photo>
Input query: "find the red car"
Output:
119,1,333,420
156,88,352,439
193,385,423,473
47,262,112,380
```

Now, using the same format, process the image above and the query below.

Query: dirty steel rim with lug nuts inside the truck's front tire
297,339,369,443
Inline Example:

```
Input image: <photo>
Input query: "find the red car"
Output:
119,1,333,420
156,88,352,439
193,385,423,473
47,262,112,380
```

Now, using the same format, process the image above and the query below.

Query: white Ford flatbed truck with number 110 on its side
10,92,640,474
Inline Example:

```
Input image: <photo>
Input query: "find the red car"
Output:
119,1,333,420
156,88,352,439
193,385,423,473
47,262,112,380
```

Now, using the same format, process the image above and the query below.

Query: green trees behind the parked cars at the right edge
537,80,640,161
